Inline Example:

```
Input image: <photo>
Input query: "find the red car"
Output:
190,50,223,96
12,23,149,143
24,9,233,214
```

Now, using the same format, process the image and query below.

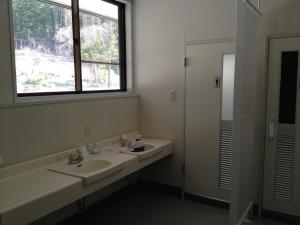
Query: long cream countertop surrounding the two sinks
0,134,172,225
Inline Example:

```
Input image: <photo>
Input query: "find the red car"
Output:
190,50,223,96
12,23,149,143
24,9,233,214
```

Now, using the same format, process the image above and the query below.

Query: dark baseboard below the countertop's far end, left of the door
136,179,182,198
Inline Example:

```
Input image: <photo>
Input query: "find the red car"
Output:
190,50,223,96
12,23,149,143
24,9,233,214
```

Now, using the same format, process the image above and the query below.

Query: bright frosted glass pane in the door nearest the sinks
222,54,235,121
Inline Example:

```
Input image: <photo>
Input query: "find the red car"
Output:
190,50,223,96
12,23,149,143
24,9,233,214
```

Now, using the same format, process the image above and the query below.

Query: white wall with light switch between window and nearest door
133,0,235,186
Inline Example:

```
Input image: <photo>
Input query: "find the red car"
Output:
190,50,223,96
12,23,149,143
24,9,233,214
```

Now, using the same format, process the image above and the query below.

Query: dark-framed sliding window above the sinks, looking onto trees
12,0,126,97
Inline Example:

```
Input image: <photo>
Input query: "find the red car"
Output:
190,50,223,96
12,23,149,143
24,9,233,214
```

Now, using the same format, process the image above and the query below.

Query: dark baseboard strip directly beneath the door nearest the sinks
184,192,230,210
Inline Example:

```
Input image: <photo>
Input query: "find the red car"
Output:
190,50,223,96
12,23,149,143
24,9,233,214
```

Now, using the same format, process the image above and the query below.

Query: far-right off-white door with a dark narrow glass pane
263,37,300,216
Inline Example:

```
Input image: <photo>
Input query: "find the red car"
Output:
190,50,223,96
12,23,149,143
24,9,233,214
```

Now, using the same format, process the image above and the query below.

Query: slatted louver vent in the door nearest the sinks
219,130,232,190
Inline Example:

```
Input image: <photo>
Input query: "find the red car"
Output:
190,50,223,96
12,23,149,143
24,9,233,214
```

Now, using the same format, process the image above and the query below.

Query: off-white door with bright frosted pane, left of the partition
185,42,235,201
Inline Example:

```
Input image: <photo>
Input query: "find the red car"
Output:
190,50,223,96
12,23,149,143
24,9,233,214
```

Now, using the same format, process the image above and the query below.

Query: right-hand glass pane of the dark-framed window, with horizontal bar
79,0,121,91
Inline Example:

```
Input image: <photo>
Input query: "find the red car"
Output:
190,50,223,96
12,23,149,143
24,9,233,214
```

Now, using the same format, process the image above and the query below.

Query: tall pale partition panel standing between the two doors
230,0,260,225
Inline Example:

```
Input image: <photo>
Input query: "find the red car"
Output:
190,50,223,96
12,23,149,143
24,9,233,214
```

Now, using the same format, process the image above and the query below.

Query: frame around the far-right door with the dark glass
258,33,300,216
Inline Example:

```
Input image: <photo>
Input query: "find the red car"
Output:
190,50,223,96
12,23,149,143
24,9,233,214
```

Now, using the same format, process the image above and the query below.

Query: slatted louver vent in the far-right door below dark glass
273,135,295,201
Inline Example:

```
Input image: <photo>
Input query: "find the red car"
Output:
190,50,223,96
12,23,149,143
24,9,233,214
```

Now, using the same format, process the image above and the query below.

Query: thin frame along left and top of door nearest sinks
181,37,236,199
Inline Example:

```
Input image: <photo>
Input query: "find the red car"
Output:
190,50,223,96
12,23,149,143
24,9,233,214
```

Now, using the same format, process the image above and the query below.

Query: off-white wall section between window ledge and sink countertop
0,97,138,165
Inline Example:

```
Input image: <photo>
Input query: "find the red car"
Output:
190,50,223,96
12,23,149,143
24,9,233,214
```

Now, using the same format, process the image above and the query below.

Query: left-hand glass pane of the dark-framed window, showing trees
12,0,75,93
